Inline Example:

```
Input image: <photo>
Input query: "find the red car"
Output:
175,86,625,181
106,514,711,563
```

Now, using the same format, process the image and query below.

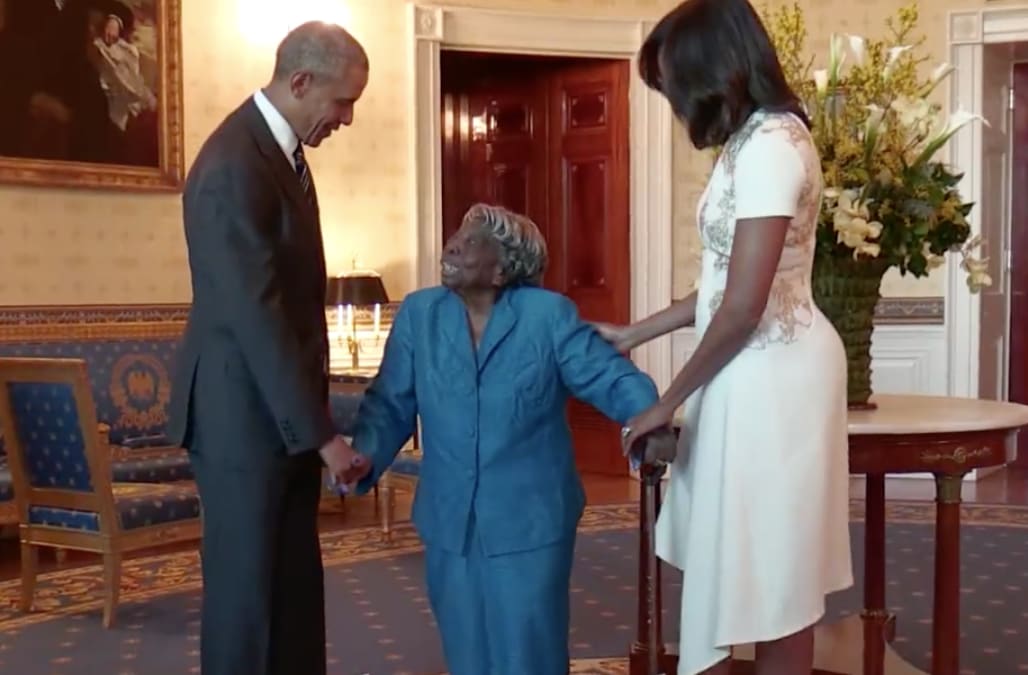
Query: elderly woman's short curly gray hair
463,203,549,286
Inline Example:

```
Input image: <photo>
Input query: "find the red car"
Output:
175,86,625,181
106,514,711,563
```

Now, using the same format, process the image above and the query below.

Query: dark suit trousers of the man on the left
190,439,326,675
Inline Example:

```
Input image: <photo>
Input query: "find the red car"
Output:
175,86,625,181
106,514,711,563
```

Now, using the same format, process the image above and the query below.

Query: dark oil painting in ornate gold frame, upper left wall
0,0,183,190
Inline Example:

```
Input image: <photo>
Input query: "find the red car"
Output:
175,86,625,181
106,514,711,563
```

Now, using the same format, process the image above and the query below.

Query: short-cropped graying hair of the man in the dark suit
274,22,368,80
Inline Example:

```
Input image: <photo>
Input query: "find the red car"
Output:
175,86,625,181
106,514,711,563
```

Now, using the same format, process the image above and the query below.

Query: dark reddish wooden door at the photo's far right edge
1009,64,1028,468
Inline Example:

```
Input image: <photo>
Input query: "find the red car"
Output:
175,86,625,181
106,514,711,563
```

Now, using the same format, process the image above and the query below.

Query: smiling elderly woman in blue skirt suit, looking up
348,204,674,675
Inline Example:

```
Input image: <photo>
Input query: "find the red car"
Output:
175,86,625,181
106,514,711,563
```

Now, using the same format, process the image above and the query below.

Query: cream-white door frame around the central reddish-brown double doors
407,3,673,390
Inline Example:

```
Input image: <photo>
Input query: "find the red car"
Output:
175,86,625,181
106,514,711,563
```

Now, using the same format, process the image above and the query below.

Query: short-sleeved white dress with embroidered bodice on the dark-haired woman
657,111,853,675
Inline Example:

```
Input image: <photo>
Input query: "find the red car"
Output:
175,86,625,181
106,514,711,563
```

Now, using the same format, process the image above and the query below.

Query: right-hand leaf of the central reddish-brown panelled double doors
548,62,631,476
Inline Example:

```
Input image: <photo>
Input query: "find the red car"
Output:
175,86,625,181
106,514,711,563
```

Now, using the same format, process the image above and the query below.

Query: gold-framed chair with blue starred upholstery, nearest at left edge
0,359,200,628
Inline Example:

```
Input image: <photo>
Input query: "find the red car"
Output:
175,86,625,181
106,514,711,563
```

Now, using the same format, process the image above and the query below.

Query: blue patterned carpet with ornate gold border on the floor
0,501,1028,675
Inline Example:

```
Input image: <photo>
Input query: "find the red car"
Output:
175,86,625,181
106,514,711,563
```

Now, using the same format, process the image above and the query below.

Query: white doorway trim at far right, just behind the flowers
946,6,1028,398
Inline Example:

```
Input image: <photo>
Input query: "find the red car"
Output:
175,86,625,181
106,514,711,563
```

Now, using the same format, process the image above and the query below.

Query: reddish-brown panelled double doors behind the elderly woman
442,52,630,476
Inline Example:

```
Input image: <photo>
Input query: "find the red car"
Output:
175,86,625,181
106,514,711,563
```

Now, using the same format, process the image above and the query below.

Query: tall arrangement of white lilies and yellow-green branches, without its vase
763,3,991,292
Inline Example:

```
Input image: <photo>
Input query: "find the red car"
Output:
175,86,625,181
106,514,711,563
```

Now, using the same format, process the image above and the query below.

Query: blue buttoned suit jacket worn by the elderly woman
354,287,657,555
